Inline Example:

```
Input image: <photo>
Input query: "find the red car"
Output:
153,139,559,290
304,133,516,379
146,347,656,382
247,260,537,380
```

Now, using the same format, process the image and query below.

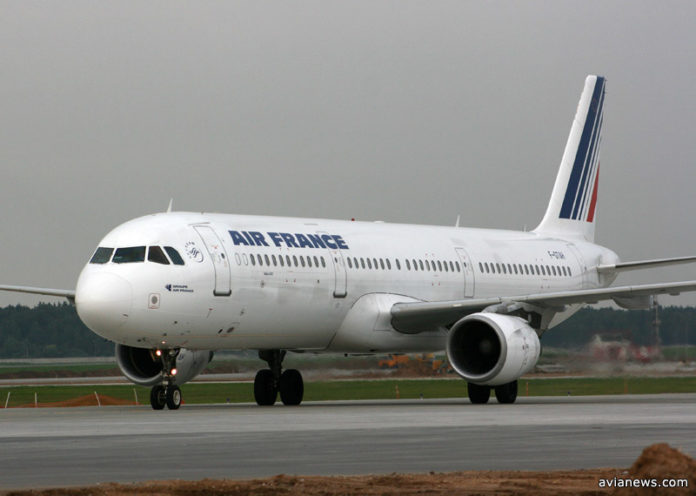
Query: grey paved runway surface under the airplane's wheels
0,394,696,489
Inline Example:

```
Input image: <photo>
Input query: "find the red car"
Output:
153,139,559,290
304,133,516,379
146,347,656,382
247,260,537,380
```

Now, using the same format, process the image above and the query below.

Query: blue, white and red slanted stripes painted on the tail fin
559,76,605,222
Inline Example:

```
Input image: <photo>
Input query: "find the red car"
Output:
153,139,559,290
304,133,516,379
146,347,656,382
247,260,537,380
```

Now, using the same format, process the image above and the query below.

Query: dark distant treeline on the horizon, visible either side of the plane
0,303,696,358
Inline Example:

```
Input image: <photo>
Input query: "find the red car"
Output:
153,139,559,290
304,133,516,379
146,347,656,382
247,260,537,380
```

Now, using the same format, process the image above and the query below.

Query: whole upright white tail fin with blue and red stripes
534,76,606,241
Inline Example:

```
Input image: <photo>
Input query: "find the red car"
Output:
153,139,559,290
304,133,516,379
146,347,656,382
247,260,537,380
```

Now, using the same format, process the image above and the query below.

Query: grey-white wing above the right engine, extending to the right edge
391,281,696,334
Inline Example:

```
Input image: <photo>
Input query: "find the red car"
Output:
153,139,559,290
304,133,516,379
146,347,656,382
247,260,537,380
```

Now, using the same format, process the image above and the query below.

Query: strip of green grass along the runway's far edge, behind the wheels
0,377,696,407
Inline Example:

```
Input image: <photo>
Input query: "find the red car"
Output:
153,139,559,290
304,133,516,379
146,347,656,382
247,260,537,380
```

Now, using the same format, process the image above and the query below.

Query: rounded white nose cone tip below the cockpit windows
75,272,133,337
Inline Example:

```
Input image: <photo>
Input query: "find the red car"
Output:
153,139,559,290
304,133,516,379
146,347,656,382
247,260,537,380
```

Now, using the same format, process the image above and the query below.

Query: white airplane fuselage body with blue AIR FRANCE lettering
76,213,618,353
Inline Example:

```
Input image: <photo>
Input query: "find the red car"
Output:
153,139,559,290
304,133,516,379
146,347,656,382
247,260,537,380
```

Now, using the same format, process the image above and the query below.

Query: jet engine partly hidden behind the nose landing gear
116,344,213,386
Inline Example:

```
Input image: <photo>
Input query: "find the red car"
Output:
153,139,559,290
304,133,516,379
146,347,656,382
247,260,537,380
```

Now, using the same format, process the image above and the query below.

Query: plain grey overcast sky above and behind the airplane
0,0,696,306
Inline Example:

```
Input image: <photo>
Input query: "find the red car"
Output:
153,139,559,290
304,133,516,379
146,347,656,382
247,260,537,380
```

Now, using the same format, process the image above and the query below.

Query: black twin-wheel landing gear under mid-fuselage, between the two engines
254,350,304,406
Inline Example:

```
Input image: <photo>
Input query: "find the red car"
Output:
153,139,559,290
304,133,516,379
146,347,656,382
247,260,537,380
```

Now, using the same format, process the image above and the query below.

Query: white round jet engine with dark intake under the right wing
447,313,541,386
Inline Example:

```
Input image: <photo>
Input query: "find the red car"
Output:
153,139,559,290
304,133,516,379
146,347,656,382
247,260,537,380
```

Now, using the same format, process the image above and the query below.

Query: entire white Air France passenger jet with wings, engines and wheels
0,76,696,410
